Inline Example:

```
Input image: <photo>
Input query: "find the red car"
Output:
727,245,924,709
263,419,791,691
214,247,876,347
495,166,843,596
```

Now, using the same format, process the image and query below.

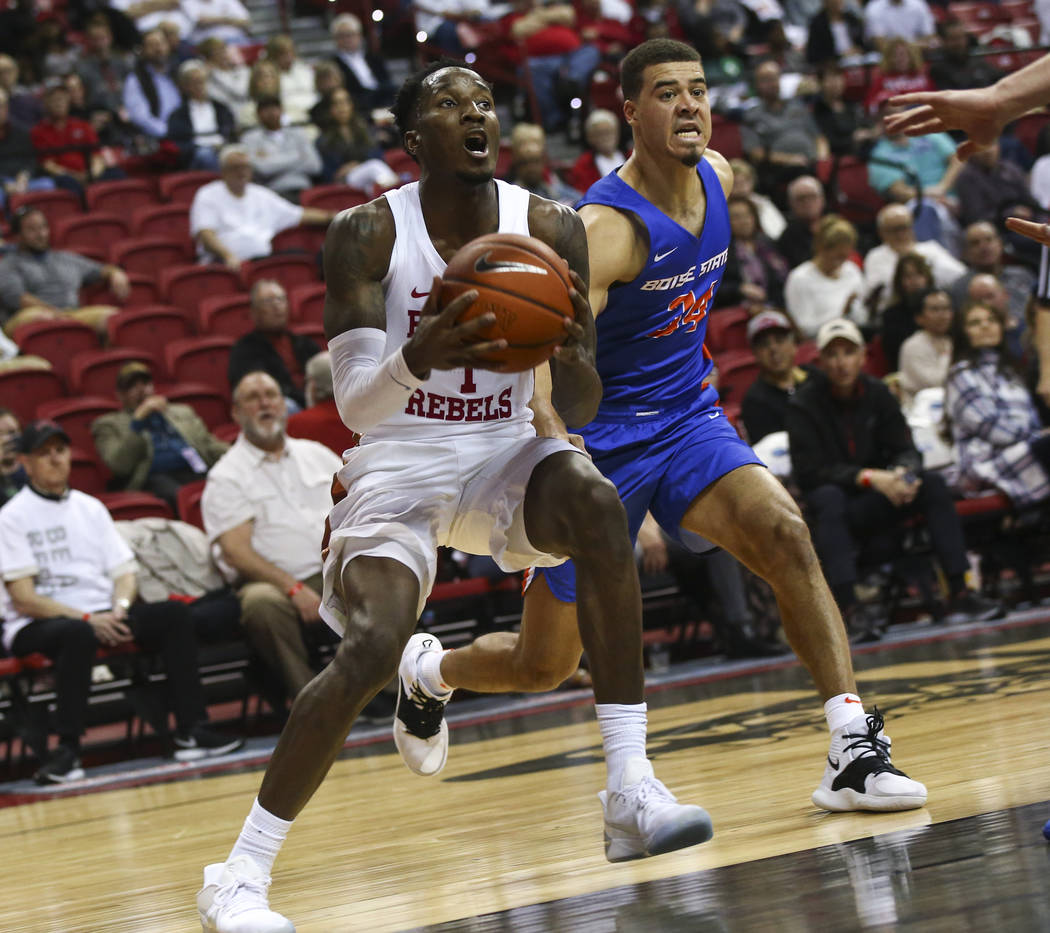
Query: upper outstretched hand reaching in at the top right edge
885,87,1006,160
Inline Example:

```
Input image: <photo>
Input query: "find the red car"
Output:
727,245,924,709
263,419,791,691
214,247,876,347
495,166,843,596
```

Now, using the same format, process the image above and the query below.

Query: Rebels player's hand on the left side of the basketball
402,276,507,379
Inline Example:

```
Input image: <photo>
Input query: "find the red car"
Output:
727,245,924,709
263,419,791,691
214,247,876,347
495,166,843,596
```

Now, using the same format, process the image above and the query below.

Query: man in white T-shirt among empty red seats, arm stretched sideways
190,146,333,270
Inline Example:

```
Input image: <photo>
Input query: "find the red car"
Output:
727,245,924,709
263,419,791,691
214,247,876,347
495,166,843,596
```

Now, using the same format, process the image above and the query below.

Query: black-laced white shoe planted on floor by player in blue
813,707,926,812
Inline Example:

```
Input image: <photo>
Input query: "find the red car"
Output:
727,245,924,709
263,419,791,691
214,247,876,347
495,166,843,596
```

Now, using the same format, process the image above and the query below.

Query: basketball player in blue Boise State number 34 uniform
399,39,926,810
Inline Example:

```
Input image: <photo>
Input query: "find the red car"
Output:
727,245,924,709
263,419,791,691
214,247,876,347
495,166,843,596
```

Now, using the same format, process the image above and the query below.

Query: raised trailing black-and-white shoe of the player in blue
394,632,452,777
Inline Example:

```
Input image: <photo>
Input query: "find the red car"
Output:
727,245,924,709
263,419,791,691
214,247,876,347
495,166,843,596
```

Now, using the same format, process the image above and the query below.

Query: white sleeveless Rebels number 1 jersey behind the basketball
361,181,534,444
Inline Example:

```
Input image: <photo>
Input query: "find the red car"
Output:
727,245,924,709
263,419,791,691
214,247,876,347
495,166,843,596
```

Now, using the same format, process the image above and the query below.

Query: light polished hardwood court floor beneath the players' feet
0,622,1050,933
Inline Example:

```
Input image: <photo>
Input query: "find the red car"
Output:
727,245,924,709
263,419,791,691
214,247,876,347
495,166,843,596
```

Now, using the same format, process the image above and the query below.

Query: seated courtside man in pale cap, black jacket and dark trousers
788,320,1003,637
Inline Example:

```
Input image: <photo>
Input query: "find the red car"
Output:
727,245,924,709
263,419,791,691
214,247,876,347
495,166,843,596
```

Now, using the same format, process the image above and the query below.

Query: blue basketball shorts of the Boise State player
536,394,762,602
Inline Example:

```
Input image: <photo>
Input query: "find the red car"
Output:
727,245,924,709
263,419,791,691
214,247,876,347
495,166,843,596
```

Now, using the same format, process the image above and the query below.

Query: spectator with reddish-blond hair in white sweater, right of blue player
784,214,867,340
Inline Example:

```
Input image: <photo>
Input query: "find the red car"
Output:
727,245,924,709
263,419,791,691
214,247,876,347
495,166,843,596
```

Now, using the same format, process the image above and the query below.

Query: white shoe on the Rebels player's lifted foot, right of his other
599,758,714,862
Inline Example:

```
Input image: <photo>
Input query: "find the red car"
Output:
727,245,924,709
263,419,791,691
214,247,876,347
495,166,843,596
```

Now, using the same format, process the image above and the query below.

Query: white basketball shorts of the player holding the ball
320,433,580,634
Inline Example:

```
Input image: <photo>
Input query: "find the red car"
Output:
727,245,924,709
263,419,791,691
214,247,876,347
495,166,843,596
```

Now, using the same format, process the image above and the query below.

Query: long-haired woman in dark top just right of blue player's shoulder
715,194,790,314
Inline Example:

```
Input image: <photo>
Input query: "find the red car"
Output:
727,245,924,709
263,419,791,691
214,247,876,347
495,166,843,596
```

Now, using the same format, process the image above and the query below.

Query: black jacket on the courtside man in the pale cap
788,372,922,492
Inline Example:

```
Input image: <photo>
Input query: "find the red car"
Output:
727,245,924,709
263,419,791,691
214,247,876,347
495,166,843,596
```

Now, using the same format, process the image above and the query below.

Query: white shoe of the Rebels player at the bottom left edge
197,855,295,933
